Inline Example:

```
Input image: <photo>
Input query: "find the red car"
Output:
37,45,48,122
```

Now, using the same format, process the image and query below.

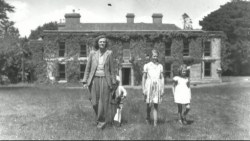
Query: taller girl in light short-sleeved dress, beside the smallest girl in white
142,50,164,126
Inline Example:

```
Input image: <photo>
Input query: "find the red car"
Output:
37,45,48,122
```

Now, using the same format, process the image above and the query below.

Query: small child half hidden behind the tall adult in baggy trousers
114,76,127,126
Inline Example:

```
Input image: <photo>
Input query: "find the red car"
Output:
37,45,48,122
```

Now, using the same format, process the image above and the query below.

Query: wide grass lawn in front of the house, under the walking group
0,82,250,140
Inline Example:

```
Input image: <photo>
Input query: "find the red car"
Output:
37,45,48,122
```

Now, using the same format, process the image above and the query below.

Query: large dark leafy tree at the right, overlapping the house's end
199,0,250,75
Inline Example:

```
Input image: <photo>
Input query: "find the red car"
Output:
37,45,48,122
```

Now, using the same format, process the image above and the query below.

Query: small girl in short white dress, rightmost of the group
172,64,191,124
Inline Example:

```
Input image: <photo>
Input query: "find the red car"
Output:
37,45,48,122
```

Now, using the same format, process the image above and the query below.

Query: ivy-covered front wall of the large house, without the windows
33,31,224,85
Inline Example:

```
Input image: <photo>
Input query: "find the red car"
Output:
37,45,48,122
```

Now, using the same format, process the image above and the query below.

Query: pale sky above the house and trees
5,0,231,37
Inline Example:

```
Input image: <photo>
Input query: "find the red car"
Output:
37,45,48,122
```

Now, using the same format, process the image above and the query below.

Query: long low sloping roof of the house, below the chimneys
59,23,181,31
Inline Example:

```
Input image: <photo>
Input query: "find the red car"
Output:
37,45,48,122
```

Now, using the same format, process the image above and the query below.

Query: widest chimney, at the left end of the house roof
64,11,81,26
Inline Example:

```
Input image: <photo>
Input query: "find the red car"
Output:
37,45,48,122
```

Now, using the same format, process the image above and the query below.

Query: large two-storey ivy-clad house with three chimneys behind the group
39,12,224,86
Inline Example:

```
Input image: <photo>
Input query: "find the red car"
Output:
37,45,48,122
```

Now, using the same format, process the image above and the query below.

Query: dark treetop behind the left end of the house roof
29,22,58,40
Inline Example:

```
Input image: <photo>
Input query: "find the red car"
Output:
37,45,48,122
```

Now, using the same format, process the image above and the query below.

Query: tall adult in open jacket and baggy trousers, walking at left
83,35,116,129
